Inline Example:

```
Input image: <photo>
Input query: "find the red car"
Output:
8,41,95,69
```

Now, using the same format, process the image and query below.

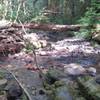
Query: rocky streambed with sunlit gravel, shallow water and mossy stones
1,32,100,100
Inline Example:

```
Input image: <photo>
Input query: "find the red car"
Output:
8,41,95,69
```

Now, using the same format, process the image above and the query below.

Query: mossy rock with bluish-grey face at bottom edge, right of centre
47,81,85,100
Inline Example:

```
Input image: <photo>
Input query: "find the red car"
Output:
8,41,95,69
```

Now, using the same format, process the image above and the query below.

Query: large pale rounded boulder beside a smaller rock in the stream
64,63,85,76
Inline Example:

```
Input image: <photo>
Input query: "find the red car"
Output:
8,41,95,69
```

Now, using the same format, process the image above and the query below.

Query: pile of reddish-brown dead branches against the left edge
0,22,23,56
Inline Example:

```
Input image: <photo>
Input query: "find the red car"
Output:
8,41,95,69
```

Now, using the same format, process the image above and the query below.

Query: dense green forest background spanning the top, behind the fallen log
0,0,100,38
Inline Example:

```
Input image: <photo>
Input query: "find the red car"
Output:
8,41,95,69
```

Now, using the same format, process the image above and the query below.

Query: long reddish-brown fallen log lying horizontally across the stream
12,23,83,32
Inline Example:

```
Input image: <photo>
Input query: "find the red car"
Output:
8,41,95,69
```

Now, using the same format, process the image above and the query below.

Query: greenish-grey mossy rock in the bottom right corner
77,76,100,100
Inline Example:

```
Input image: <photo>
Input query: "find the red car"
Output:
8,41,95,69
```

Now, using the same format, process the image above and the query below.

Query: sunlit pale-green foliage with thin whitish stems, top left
0,0,49,22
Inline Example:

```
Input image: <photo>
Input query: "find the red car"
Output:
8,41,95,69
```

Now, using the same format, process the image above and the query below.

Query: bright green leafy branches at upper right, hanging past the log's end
75,0,100,39
